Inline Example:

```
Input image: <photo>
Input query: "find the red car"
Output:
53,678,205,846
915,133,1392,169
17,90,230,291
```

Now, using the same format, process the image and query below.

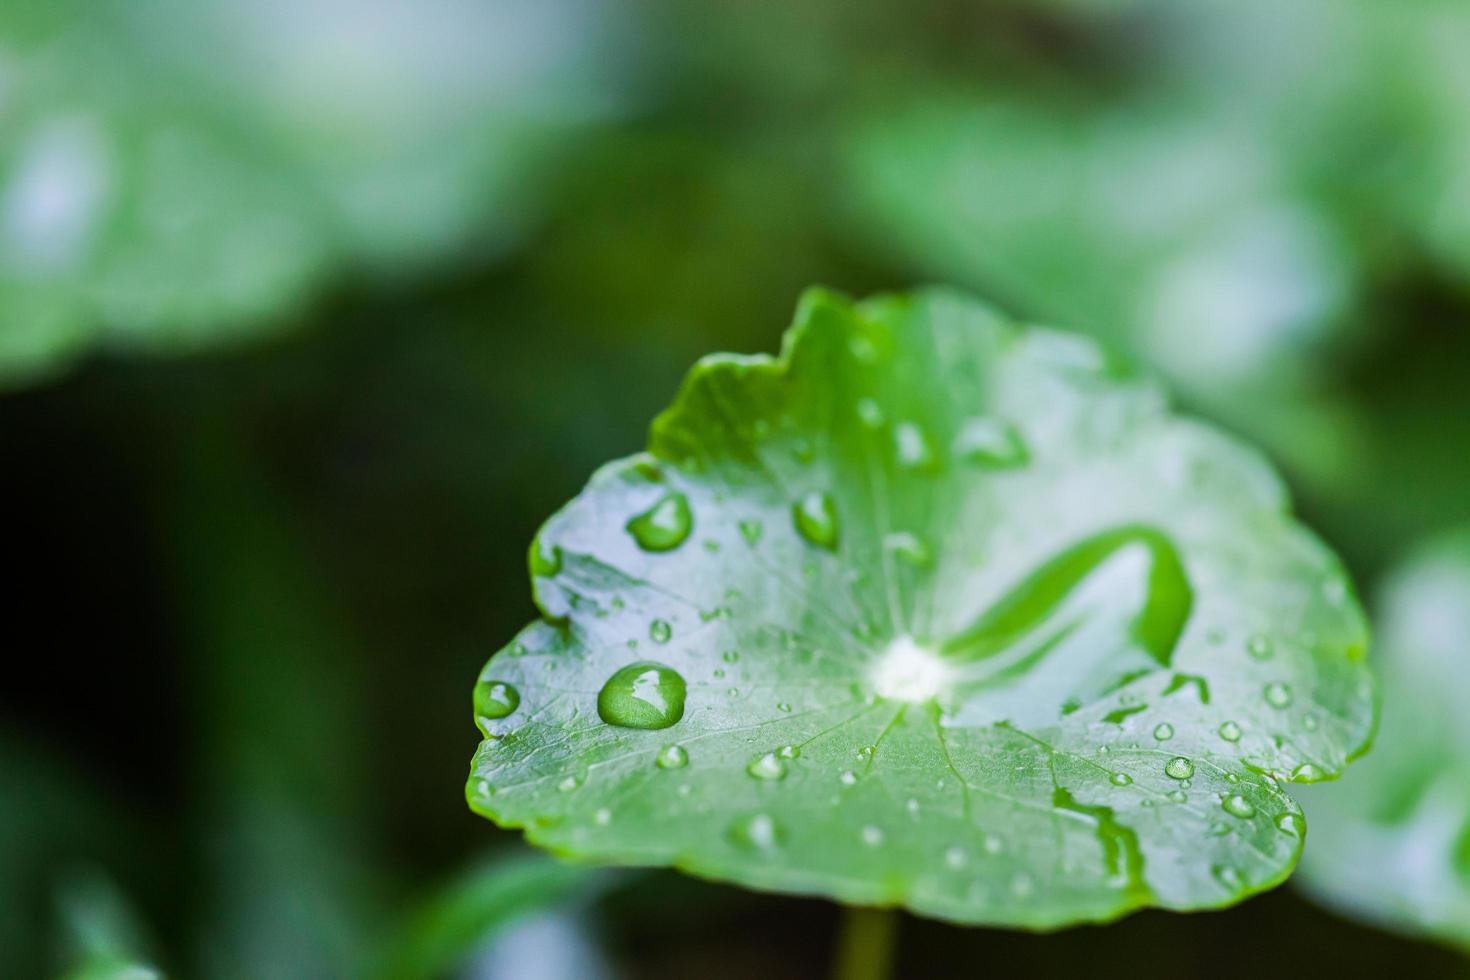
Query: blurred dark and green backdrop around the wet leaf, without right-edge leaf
0,0,1470,979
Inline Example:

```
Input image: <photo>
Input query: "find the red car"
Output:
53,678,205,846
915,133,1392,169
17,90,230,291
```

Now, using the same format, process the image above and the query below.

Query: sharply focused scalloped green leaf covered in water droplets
466,291,1373,927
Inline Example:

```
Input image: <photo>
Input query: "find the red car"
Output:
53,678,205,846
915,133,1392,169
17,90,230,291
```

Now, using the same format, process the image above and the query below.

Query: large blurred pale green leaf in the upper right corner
848,0,1470,555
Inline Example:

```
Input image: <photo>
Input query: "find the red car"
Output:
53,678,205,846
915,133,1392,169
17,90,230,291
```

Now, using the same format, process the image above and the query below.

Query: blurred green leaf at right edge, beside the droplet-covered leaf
1299,530,1470,951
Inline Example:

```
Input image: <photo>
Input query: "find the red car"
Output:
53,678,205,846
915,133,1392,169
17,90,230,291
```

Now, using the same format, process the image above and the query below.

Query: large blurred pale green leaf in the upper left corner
0,0,616,385
